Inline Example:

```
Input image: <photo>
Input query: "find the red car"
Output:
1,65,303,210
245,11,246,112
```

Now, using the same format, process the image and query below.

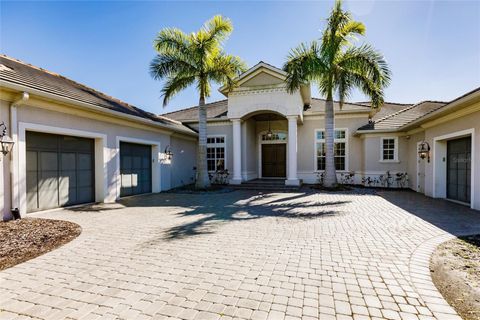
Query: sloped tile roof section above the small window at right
358,101,447,131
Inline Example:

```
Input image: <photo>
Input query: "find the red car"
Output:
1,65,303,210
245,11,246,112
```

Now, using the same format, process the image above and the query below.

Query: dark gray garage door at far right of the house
447,137,472,203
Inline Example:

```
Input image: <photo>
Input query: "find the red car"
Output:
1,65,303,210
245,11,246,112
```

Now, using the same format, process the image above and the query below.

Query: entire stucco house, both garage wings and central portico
0,56,480,219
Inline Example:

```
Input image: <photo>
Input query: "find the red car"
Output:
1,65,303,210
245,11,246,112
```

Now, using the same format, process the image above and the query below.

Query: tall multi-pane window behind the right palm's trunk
315,129,347,171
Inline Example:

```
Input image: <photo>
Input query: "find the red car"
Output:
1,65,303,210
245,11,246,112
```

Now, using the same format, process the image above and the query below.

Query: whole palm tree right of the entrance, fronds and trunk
284,0,390,187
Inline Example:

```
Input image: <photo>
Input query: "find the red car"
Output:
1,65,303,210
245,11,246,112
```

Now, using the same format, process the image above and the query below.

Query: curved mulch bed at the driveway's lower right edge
430,234,480,320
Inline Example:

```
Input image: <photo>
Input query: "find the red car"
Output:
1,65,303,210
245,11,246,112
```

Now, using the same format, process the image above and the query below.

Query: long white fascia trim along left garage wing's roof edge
0,80,197,136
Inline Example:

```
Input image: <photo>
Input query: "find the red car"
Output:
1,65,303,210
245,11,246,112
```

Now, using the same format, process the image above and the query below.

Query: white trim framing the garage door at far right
433,128,478,209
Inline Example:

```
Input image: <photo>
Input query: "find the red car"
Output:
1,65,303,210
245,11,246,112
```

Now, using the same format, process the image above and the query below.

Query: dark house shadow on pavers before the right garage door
377,190,480,236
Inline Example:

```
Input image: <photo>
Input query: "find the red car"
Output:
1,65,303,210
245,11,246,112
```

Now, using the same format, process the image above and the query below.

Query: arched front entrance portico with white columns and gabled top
220,62,310,186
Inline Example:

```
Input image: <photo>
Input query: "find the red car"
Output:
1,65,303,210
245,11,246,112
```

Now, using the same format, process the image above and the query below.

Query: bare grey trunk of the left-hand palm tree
195,93,210,189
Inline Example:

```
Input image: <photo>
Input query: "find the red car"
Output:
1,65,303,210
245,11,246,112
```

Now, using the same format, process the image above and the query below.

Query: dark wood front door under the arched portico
262,143,287,178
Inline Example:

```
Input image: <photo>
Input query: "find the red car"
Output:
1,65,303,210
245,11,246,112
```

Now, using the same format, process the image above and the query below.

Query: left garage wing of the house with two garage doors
0,56,198,219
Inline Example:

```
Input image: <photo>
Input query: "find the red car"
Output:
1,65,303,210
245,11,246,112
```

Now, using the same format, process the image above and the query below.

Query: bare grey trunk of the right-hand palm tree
323,95,337,188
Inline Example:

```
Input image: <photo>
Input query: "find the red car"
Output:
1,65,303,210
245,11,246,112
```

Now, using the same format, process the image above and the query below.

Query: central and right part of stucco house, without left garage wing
163,62,480,209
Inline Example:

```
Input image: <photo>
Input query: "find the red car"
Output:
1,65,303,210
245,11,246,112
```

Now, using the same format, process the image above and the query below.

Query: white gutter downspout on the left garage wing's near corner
10,92,30,218
